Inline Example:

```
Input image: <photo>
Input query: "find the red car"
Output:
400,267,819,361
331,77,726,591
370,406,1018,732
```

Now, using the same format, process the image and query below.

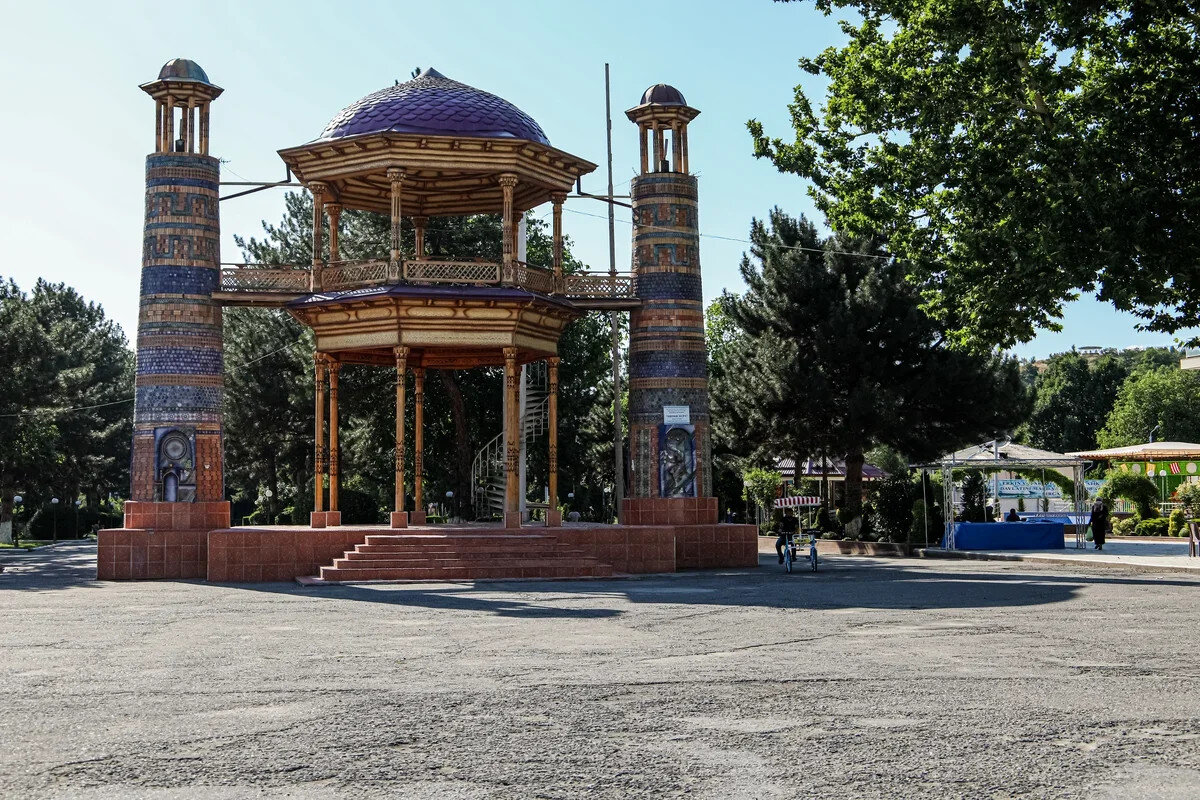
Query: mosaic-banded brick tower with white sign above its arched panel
625,84,716,523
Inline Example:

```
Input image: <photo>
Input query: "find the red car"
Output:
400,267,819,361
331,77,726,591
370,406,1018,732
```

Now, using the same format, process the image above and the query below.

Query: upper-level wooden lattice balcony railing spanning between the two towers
214,259,641,311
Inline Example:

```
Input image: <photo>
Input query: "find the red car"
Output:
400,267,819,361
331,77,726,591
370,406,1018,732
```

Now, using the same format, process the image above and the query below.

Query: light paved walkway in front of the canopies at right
919,536,1200,575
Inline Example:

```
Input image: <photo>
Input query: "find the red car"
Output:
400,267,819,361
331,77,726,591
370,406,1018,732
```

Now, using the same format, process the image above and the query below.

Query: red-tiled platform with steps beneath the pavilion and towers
97,513,758,582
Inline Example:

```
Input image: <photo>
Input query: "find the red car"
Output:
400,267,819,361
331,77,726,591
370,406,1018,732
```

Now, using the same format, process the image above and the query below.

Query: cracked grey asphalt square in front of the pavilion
0,543,1200,800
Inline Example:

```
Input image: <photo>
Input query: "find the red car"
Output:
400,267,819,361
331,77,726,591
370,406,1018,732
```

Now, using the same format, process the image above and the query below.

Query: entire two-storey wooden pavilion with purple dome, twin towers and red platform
105,60,757,581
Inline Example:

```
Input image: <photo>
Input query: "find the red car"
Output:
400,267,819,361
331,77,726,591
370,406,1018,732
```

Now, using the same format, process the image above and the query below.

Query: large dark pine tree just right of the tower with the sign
713,209,1027,512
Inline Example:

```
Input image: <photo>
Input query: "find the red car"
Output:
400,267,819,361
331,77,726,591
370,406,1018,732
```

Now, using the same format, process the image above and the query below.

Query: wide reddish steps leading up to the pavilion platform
318,533,612,582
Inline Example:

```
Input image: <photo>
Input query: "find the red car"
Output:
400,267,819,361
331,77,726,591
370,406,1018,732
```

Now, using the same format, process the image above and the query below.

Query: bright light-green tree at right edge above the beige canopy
1097,366,1200,447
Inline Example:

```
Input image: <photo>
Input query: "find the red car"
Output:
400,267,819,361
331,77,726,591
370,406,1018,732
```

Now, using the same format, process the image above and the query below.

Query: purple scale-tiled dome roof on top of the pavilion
318,67,550,145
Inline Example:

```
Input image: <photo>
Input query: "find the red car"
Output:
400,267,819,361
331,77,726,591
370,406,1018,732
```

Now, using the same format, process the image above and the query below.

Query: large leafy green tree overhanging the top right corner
749,0,1200,347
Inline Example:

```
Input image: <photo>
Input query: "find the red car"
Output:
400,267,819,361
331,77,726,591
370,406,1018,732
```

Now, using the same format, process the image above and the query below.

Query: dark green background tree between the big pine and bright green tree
1020,350,1129,452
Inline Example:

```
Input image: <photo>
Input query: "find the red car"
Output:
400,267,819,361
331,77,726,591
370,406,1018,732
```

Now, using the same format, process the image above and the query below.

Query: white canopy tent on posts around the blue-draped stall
913,441,1087,549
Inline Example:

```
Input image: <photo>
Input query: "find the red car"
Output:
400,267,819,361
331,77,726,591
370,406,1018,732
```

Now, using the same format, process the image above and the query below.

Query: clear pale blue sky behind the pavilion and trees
0,0,1170,356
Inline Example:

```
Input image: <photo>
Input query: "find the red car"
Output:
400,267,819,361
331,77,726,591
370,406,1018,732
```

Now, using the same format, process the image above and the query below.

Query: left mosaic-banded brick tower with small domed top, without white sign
130,59,224,503
